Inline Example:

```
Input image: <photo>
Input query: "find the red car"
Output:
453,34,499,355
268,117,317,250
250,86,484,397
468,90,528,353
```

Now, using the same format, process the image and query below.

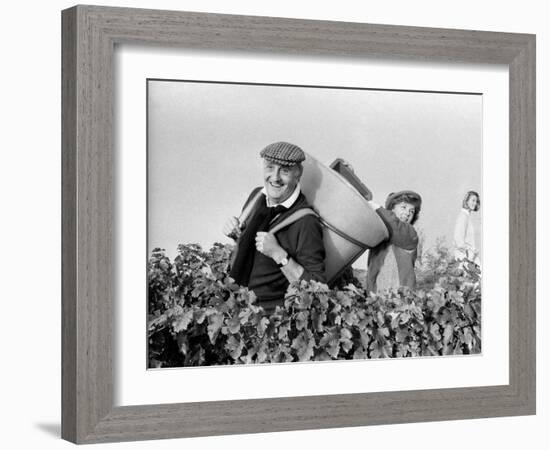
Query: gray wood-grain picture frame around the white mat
62,6,535,443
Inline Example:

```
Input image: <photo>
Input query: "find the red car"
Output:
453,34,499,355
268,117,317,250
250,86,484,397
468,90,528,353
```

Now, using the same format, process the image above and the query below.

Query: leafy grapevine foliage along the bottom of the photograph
147,243,481,368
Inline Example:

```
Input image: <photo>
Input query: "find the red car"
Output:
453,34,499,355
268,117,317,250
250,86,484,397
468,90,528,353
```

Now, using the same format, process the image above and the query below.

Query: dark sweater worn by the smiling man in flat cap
238,188,326,303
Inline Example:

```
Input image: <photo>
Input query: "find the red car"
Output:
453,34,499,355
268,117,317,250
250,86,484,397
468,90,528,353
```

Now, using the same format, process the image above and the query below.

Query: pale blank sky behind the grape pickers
148,81,483,269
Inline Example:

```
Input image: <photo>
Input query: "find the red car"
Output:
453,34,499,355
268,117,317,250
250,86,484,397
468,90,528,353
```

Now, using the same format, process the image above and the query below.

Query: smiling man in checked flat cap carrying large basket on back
223,142,325,312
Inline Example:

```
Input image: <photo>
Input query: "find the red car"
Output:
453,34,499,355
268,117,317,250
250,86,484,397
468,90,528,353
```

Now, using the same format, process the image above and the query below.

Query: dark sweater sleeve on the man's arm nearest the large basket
293,215,326,283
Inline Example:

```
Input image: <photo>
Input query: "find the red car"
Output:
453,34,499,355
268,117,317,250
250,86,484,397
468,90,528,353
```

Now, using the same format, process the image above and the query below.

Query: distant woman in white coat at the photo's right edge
454,191,481,265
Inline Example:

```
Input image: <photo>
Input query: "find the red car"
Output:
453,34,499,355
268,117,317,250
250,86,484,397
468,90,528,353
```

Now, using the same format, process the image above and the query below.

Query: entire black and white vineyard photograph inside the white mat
147,79,483,369
